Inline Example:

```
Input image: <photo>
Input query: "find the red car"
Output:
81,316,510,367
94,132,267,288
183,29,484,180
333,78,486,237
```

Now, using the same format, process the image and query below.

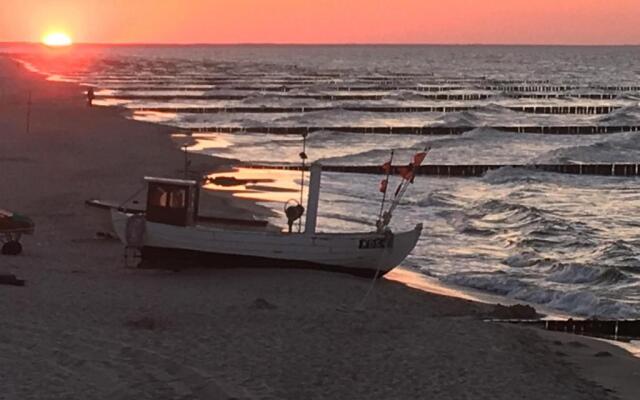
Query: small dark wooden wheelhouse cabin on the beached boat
144,177,200,226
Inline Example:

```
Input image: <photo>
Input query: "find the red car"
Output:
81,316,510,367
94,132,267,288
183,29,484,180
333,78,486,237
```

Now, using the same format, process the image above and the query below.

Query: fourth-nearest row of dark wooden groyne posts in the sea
130,105,622,115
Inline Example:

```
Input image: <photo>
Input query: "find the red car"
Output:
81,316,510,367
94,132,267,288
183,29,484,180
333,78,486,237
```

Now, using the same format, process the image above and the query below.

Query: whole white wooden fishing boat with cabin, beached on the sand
111,151,422,277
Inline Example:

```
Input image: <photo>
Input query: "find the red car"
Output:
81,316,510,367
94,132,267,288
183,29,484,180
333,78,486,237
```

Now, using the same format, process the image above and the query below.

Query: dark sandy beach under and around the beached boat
0,57,640,400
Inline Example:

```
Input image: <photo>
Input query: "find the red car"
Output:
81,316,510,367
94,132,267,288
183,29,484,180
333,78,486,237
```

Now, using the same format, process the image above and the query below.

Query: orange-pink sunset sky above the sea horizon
0,0,640,44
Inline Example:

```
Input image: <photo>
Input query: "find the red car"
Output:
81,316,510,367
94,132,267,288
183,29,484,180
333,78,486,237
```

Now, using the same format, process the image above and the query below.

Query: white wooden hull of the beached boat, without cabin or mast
112,210,422,276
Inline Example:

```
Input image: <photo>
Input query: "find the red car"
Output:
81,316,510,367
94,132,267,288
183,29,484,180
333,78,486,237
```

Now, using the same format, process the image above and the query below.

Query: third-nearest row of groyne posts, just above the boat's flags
189,125,640,136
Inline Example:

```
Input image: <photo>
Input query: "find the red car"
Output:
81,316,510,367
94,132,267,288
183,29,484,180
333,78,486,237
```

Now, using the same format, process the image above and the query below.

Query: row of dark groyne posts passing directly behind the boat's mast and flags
241,163,640,178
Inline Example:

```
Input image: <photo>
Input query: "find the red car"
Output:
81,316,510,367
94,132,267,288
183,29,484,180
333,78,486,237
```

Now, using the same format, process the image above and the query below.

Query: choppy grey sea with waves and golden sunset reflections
5,45,640,319
